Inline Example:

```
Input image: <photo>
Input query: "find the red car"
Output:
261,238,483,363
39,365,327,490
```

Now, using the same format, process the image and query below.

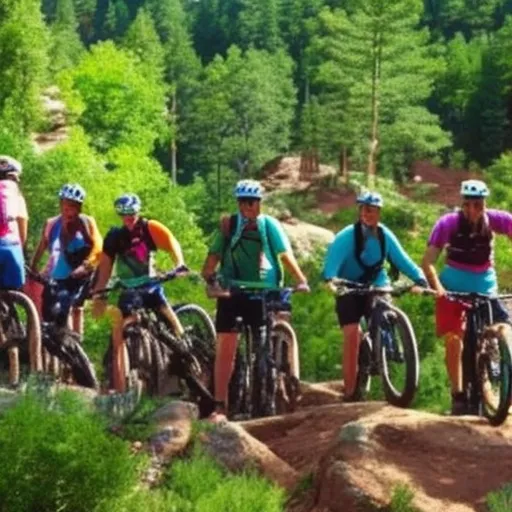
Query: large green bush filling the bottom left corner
0,392,141,512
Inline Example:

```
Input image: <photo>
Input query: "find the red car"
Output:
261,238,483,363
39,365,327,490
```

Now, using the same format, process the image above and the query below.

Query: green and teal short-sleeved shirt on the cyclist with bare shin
209,215,290,287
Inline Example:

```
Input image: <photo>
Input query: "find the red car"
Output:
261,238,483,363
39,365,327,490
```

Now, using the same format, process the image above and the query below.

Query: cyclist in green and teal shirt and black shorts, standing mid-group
202,180,309,420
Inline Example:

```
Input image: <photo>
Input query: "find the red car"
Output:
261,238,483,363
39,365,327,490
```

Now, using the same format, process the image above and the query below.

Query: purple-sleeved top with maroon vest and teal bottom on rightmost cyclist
428,210,512,294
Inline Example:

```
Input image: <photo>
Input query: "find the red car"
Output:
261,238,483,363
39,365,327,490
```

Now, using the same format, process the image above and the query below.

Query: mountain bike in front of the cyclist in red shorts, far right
447,292,512,426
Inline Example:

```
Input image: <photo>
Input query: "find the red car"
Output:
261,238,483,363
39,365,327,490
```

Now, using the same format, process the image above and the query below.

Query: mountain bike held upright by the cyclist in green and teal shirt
211,285,300,419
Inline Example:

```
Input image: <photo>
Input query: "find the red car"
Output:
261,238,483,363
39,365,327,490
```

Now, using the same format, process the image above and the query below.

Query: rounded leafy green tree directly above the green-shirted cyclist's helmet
184,46,295,176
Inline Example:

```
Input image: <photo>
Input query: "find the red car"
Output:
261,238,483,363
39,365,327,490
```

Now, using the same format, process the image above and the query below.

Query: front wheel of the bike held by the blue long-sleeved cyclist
376,304,420,407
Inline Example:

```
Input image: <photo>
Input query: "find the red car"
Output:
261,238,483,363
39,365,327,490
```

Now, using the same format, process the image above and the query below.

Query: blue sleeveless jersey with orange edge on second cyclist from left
43,214,102,280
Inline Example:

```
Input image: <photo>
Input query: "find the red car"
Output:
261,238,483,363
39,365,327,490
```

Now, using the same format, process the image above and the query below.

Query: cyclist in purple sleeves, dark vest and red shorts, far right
423,180,512,415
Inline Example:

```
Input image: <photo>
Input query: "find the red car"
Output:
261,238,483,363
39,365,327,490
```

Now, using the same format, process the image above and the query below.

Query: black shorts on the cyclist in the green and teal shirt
215,295,264,333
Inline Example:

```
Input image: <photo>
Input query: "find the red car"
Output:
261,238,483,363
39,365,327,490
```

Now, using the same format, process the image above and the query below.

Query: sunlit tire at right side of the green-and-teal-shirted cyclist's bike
272,320,300,414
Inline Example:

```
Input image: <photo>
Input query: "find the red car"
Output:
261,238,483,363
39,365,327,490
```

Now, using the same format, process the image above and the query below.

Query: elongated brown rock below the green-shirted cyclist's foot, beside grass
198,423,298,489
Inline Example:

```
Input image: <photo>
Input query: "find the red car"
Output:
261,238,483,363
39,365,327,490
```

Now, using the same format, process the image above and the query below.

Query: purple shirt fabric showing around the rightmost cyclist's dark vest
428,210,512,272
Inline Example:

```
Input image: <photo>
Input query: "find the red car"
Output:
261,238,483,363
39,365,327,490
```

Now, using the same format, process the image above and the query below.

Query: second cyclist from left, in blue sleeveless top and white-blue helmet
31,183,102,336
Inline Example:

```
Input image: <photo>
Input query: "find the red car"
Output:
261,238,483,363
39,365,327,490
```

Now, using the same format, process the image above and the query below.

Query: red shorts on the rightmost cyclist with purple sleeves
436,297,510,336
